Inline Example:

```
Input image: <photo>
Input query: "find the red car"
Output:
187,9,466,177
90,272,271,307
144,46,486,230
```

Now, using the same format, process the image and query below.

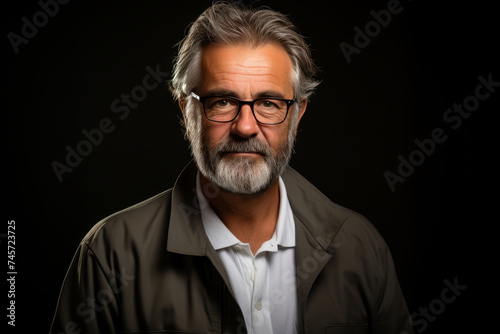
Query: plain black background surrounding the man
0,0,500,333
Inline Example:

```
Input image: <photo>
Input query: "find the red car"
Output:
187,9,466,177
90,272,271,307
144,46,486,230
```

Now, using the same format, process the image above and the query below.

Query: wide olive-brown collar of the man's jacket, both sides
167,161,346,256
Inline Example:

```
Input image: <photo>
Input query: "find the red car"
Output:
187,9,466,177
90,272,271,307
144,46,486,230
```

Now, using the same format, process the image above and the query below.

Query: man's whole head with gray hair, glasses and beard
171,3,318,194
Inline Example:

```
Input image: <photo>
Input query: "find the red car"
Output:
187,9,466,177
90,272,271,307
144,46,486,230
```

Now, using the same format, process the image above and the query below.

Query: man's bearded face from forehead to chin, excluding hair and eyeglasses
186,44,306,194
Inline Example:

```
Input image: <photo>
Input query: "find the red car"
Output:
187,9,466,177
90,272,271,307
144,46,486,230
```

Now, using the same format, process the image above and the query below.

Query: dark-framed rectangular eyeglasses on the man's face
191,92,296,125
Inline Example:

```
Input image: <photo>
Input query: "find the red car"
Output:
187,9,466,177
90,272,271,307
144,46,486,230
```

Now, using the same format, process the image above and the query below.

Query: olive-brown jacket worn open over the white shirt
51,163,413,334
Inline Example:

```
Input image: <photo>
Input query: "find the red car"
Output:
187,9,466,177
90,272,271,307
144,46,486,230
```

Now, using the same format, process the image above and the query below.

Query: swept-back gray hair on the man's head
169,2,319,101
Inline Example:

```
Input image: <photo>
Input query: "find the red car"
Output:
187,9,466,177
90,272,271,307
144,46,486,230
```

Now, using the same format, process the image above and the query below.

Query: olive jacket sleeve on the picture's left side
50,242,119,334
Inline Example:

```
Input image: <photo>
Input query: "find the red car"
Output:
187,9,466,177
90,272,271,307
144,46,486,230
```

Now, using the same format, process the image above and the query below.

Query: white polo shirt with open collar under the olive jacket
196,173,297,334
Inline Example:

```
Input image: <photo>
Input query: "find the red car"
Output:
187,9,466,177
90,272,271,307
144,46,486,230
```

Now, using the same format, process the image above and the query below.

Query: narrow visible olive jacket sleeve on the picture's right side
373,248,413,334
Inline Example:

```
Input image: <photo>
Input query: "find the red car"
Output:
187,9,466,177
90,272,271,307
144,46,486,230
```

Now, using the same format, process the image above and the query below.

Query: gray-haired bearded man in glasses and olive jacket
52,3,412,334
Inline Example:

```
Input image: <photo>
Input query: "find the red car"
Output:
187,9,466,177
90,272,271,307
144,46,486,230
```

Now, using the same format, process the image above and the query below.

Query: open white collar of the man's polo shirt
196,172,295,250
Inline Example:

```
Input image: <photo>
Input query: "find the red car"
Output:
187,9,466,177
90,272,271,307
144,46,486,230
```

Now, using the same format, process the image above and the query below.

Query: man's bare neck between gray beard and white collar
200,174,280,254
